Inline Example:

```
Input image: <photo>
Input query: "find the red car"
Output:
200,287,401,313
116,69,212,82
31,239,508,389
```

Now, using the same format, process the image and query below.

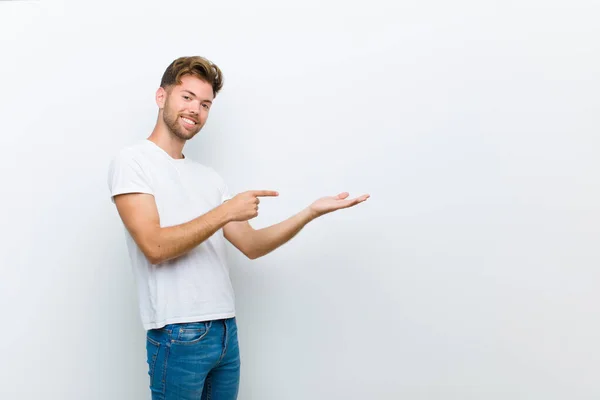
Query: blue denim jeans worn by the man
146,318,240,400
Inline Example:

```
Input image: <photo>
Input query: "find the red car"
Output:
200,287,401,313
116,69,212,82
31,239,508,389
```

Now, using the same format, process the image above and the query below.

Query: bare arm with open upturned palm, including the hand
223,192,369,260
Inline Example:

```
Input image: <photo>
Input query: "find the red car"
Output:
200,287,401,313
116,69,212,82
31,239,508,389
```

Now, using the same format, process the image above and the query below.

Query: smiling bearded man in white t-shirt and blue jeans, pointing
108,57,369,400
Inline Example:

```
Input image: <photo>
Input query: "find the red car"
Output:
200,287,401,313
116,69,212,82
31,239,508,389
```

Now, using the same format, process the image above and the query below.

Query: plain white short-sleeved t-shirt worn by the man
108,140,235,330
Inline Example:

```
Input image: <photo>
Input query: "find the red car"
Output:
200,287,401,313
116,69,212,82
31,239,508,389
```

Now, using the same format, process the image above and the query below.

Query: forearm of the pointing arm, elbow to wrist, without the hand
147,206,229,264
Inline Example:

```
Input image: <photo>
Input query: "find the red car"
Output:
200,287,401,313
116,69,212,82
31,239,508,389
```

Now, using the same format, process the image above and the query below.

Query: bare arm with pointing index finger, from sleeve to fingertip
114,190,277,264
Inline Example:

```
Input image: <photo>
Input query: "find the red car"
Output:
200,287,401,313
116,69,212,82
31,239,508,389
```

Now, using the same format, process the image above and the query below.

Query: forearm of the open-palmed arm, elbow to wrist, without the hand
250,208,318,258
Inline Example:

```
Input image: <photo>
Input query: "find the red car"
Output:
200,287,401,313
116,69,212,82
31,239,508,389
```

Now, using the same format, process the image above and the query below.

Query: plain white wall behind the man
0,0,600,400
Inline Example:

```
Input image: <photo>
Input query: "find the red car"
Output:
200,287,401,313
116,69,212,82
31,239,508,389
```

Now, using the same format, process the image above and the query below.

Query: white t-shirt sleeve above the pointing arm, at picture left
108,151,154,203
